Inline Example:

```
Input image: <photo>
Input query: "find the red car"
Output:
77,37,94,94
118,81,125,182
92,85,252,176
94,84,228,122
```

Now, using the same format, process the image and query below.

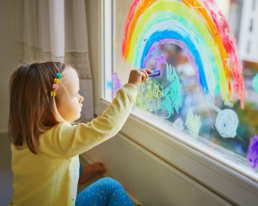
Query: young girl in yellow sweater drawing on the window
9,62,151,206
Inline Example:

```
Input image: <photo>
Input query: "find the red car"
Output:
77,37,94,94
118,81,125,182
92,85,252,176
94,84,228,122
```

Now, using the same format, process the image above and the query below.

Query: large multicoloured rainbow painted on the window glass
122,0,245,109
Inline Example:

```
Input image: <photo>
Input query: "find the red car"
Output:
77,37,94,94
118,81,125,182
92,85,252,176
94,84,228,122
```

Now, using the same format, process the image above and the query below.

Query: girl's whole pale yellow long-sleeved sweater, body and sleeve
9,84,137,206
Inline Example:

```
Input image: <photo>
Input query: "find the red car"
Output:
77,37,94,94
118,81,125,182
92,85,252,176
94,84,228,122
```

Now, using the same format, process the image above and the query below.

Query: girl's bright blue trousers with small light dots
75,165,134,206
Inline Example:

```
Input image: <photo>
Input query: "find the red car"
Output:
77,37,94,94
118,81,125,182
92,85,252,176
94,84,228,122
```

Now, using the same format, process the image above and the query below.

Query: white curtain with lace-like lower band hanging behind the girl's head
16,0,93,119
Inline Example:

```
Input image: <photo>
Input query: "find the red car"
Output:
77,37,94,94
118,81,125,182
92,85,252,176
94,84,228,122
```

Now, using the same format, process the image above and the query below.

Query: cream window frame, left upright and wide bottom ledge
95,0,258,206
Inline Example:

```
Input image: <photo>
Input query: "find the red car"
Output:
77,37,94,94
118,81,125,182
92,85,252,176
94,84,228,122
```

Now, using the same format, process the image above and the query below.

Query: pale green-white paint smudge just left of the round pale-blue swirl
185,109,202,138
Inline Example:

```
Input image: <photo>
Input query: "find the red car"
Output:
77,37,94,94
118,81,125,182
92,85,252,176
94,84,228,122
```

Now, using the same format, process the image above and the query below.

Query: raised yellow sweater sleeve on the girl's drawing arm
56,84,138,157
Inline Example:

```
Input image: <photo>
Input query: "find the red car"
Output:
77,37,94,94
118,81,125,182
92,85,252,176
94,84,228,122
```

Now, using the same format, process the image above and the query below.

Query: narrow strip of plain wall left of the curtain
0,0,17,133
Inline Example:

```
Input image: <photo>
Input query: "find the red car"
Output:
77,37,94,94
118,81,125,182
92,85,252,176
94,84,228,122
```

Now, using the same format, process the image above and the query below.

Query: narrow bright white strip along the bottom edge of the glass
131,107,258,182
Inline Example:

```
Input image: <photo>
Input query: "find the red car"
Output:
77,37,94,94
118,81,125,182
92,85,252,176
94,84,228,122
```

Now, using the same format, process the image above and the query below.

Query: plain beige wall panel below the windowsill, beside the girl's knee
83,134,231,206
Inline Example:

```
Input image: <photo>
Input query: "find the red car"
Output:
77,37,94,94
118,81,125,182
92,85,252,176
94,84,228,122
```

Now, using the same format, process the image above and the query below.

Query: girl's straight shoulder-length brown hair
8,62,71,154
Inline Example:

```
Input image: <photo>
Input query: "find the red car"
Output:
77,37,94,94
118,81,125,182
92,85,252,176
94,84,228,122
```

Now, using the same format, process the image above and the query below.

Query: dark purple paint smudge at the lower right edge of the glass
246,135,258,168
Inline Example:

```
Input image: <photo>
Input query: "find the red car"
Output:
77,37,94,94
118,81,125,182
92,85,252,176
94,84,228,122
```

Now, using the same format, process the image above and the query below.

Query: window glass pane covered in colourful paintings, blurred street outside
105,0,258,175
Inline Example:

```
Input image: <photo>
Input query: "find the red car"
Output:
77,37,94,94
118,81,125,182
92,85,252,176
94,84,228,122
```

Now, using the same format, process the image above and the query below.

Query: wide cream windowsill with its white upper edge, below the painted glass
95,100,258,202
